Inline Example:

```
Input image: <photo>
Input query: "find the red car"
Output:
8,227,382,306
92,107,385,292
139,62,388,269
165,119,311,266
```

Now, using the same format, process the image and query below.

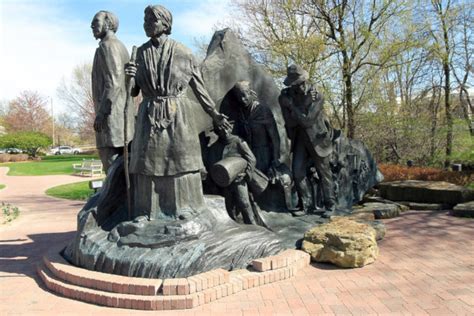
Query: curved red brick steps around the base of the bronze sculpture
37,250,310,310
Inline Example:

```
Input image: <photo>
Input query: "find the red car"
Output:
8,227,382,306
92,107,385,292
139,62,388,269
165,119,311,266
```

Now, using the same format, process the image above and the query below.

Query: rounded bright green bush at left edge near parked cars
0,132,53,157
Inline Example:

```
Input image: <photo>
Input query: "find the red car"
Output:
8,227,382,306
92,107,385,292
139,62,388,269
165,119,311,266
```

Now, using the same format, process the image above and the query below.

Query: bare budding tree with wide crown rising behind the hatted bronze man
231,0,408,138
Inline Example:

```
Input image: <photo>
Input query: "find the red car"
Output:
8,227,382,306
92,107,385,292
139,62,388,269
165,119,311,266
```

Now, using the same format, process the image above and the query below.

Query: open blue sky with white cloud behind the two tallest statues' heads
0,0,231,113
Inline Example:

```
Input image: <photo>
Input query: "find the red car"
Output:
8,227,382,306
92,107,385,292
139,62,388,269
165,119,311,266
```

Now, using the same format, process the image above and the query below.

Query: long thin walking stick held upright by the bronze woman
123,46,137,220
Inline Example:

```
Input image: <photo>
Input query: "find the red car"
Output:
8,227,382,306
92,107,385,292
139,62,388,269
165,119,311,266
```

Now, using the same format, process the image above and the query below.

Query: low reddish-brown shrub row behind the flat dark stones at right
378,164,474,186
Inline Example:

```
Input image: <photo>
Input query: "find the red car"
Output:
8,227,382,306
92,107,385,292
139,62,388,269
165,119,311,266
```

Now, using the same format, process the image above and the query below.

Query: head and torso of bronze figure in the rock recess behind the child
233,81,280,175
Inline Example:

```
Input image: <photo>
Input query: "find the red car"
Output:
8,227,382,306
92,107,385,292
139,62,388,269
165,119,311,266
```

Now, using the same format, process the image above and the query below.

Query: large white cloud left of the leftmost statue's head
0,1,97,112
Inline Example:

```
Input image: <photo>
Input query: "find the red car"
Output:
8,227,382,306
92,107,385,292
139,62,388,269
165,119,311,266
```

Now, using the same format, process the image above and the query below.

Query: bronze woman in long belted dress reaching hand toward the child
126,5,228,219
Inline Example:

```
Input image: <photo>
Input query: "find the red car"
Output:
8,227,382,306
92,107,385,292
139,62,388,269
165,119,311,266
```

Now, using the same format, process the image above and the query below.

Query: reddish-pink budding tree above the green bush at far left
4,91,52,135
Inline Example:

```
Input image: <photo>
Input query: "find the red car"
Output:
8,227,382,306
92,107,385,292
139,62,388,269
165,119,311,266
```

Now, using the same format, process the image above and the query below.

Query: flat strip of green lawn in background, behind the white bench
0,155,98,176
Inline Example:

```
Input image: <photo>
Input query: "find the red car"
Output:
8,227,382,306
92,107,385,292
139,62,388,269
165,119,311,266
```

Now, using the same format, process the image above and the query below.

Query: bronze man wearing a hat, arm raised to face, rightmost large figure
279,65,336,217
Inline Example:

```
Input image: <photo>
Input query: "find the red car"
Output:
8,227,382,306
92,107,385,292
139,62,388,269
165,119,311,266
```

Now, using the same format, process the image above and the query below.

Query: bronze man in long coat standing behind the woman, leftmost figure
91,11,134,172
